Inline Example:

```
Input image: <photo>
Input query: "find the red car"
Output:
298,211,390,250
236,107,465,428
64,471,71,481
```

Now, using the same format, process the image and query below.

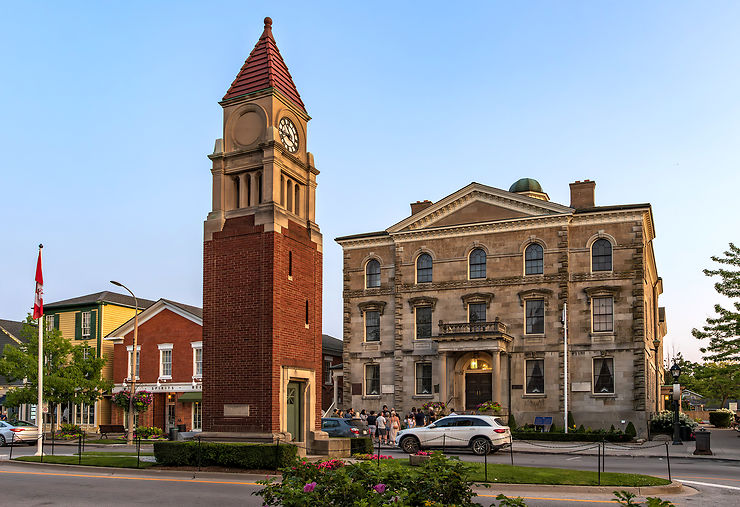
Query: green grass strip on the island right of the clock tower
372,458,670,487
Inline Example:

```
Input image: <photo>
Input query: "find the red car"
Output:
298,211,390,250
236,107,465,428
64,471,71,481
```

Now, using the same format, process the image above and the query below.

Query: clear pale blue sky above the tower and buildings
0,1,740,359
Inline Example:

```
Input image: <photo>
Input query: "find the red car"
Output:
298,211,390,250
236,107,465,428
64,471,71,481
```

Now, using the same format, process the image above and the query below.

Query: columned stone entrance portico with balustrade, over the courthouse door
434,318,512,412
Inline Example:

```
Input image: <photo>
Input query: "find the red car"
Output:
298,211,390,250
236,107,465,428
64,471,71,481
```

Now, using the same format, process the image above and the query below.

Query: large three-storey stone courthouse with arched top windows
336,179,666,433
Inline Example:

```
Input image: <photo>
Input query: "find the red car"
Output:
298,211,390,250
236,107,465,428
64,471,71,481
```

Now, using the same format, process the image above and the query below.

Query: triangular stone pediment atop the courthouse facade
387,183,573,232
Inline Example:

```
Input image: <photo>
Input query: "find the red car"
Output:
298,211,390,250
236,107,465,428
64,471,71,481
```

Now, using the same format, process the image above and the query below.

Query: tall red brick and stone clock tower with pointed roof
203,18,325,443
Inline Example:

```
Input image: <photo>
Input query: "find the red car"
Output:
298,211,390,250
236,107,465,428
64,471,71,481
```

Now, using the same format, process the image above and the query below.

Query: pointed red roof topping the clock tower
223,18,306,112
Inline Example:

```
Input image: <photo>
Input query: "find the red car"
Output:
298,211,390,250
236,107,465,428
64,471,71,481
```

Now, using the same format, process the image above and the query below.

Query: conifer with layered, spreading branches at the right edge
691,243,740,369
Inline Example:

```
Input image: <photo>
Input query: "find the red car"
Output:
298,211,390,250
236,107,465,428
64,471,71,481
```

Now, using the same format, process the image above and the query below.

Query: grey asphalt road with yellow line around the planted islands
0,446,740,507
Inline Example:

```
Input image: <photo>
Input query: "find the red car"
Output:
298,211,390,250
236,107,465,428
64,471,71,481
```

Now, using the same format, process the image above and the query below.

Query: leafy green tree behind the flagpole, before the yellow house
0,315,113,422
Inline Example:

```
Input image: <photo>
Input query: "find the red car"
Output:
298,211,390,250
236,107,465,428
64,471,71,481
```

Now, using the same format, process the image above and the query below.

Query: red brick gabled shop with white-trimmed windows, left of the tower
105,299,203,431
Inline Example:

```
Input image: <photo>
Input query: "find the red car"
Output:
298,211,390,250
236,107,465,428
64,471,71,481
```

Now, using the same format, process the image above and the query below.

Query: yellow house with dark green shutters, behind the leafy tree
44,291,154,431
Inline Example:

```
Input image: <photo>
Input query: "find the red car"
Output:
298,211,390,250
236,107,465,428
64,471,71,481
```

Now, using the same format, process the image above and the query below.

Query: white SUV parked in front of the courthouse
396,415,511,456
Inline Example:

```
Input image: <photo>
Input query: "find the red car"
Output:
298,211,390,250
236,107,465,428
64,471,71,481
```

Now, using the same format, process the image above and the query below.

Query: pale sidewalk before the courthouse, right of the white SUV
508,428,740,461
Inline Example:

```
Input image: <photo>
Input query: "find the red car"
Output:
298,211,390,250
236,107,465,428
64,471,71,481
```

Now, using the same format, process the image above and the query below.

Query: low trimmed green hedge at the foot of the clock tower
154,441,297,470
